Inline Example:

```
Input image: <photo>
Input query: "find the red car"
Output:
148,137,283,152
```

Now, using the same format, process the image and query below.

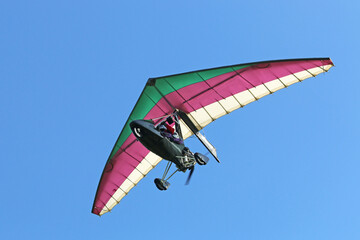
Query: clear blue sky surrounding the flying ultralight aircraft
0,0,360,240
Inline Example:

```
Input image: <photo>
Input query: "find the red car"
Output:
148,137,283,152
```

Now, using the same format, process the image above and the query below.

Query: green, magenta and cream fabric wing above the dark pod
92,58,333,215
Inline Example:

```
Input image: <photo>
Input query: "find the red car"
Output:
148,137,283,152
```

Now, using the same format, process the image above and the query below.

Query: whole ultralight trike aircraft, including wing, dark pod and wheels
92,58,334,215
